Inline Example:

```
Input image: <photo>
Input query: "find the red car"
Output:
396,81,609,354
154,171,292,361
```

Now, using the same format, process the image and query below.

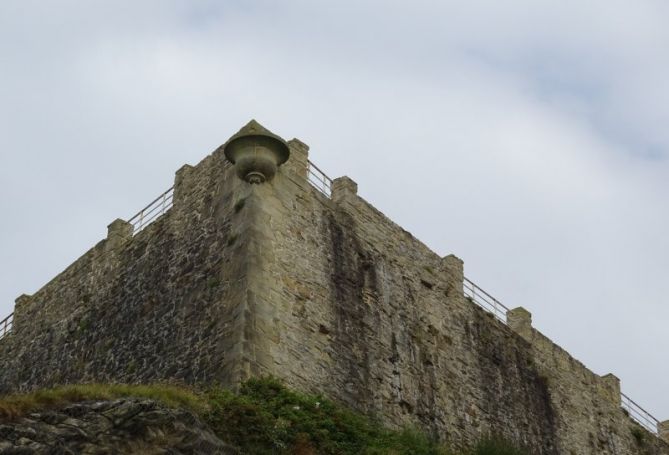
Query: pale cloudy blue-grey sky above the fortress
0,0,669,420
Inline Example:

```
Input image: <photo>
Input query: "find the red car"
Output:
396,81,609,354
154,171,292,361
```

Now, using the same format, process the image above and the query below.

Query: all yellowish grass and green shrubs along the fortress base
0,378,524,455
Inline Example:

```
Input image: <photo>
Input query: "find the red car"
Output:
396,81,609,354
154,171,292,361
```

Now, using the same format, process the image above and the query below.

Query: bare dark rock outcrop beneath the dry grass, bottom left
0,399,234,455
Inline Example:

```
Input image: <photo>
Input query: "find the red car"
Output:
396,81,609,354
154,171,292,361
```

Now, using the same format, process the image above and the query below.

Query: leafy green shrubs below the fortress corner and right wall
206,378,525,455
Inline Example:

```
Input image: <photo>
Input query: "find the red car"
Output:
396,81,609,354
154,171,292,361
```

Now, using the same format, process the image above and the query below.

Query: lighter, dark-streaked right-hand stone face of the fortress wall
248,147,669,454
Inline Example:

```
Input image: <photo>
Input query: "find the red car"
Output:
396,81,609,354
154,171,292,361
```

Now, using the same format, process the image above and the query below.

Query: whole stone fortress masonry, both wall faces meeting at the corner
0,123,669,455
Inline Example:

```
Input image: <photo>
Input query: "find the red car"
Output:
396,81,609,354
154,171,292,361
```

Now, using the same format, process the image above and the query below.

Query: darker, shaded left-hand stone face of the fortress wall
0,149,253,392
